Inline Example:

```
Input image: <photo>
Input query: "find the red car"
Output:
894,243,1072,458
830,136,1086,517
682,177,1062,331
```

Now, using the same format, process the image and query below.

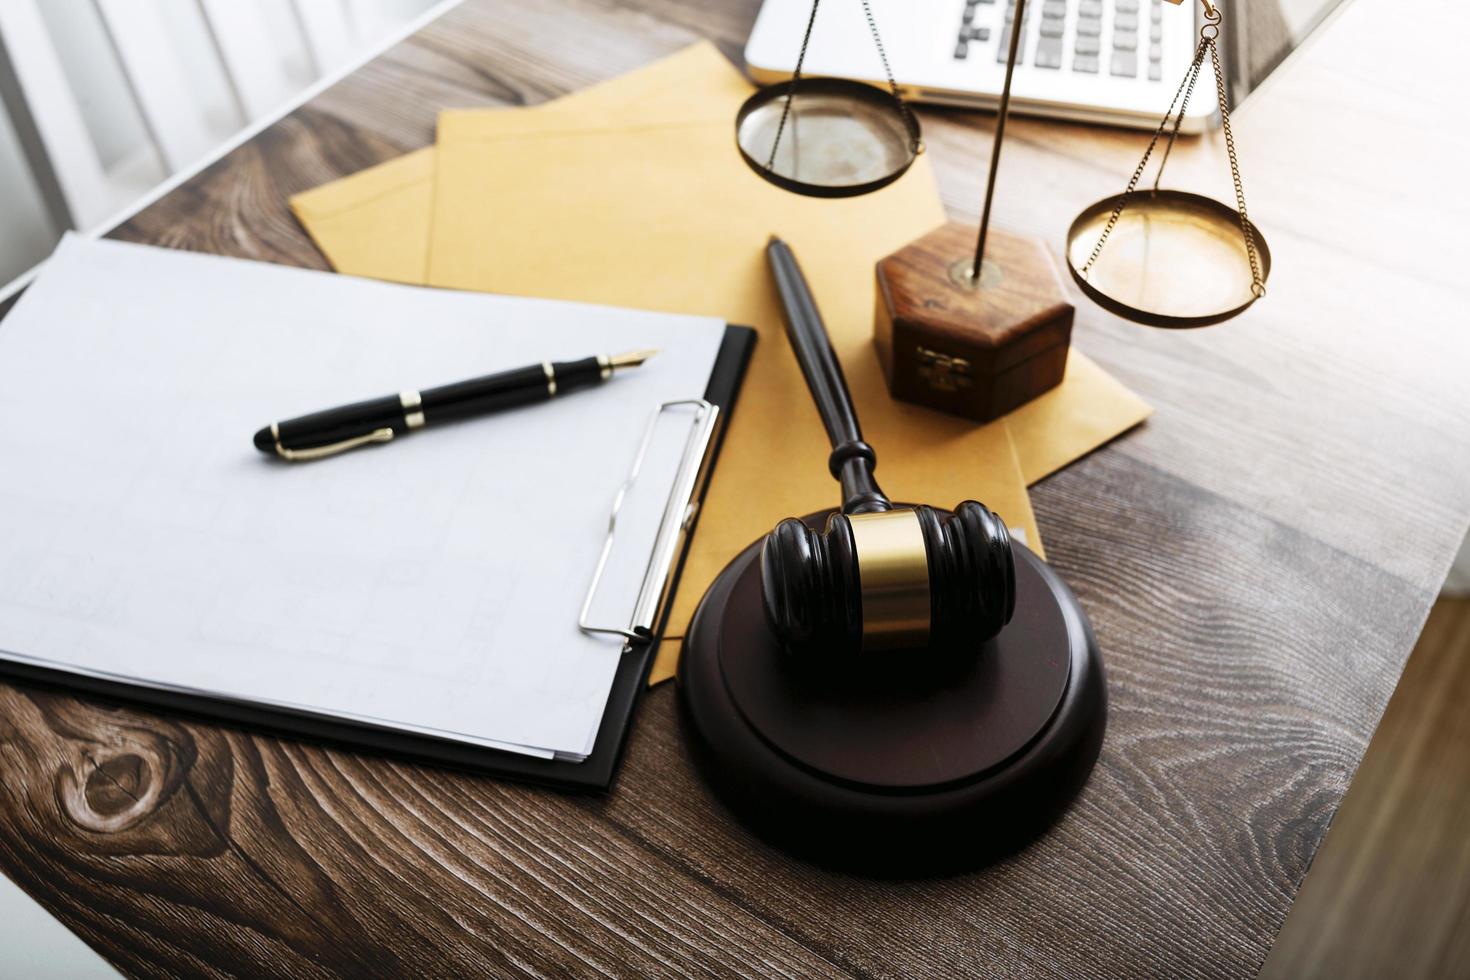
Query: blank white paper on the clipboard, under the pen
0,238,723,757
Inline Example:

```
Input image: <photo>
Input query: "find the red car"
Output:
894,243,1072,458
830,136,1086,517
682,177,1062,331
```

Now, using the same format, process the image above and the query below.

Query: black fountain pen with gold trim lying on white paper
256,351,657,463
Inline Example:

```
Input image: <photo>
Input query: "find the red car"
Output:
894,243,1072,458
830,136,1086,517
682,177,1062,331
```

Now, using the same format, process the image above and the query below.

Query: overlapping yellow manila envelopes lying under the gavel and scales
293,44,1148,682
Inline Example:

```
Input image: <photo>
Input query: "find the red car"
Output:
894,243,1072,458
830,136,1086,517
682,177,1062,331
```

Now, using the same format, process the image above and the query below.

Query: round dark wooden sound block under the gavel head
678,511,1107,876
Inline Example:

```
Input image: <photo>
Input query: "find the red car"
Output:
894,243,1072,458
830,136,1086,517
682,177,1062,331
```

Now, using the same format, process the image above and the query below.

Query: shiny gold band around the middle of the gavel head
848,510,929,651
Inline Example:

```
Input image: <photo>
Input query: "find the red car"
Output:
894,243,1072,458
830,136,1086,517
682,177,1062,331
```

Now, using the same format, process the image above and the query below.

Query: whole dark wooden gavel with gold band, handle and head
760,238,1016,658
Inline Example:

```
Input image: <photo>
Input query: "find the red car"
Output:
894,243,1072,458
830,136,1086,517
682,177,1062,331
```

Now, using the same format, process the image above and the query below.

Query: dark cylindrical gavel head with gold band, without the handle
760,500,1016,655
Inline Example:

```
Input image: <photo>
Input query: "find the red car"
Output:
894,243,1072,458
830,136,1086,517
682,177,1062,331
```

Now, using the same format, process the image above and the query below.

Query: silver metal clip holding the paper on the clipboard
576,398,720,644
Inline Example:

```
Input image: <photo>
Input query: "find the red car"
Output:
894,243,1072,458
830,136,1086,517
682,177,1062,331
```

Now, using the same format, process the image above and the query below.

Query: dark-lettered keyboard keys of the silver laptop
954,0,1164,81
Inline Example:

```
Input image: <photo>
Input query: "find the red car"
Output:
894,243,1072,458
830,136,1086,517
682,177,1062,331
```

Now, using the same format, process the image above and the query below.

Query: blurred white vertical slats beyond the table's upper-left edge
0,0,441,295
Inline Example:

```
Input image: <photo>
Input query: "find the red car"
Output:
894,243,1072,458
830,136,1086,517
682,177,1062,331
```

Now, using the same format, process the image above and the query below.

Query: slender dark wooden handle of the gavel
766,237,892,514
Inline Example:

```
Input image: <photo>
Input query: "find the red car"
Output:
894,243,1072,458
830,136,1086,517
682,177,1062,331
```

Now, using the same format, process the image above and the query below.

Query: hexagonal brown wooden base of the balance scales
873,222,1075,422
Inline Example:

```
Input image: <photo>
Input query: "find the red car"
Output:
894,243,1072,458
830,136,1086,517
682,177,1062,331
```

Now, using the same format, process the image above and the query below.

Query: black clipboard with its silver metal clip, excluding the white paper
0,325,757,792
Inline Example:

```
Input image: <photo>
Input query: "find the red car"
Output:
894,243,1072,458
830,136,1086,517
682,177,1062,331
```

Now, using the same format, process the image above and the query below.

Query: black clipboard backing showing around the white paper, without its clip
0,325,756,792
